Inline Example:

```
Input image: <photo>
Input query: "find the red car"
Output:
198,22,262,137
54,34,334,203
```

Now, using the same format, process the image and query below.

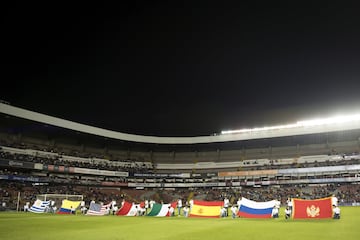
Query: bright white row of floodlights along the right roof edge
221,114,360,134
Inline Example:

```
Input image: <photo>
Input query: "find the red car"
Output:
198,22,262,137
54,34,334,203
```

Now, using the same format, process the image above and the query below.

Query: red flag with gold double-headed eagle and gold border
292,197,333,219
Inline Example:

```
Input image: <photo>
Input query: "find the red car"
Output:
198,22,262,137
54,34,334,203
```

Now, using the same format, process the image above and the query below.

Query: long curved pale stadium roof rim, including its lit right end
0,103,360,144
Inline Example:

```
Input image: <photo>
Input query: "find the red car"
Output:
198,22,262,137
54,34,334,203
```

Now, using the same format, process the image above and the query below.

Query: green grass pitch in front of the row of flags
0,207,360,240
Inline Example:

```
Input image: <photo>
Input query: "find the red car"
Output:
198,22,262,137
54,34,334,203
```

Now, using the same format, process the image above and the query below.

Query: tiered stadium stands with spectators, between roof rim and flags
0,104,360,210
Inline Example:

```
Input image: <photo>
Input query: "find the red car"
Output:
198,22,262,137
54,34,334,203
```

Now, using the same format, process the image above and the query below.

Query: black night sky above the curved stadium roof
0,1,360,136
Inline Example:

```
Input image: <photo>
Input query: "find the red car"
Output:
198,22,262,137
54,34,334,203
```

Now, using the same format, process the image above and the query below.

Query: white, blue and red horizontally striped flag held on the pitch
238,197,276,218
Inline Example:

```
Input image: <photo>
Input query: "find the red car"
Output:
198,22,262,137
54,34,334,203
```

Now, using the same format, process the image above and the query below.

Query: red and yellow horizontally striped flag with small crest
189,200,224,218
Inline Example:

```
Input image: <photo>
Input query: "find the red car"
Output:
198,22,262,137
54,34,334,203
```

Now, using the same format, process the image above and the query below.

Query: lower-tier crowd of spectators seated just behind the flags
0,181,360,209
